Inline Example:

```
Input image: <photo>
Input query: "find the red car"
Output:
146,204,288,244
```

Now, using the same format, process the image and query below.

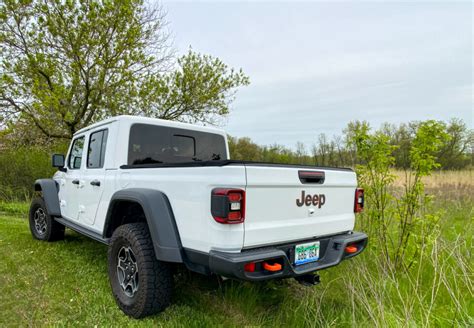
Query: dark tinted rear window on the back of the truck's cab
128,124,227,165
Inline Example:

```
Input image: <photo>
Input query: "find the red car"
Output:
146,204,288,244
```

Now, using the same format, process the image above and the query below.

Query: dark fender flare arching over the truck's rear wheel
103,188,183,263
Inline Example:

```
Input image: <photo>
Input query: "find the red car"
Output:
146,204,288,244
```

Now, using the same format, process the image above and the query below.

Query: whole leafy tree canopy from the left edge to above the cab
0,0,249,139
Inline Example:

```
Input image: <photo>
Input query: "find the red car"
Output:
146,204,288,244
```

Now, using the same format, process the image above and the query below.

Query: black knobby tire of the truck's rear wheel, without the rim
108,223,173,318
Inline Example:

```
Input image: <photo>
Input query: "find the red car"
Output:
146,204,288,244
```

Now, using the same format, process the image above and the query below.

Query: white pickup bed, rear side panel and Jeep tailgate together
120,160,357,251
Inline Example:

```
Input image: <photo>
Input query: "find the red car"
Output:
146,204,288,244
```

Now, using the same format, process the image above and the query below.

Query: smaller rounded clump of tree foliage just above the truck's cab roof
136,49,249,124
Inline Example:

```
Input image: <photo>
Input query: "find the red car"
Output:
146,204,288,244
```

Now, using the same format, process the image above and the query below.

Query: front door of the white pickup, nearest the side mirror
59,136,85,220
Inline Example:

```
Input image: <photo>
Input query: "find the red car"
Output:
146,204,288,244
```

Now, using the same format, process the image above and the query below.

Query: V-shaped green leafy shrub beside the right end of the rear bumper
348,121,448,269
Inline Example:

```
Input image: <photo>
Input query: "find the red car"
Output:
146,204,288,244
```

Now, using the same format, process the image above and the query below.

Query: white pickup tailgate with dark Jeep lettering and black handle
244,165,357,248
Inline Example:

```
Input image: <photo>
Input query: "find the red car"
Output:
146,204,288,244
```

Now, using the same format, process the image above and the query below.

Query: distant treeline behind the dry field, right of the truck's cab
229,119,474,170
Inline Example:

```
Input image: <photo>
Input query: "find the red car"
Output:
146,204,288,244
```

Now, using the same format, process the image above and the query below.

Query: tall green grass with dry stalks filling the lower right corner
272,229,474,327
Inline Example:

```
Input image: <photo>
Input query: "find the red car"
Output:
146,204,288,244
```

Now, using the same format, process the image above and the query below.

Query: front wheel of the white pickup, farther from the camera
28,197,65,241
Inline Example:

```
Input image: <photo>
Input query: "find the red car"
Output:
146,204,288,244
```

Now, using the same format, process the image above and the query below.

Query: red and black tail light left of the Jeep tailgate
211,188,245,224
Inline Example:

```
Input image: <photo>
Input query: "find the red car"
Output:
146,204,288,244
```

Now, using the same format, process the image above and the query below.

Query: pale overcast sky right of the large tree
161,1,474,148
